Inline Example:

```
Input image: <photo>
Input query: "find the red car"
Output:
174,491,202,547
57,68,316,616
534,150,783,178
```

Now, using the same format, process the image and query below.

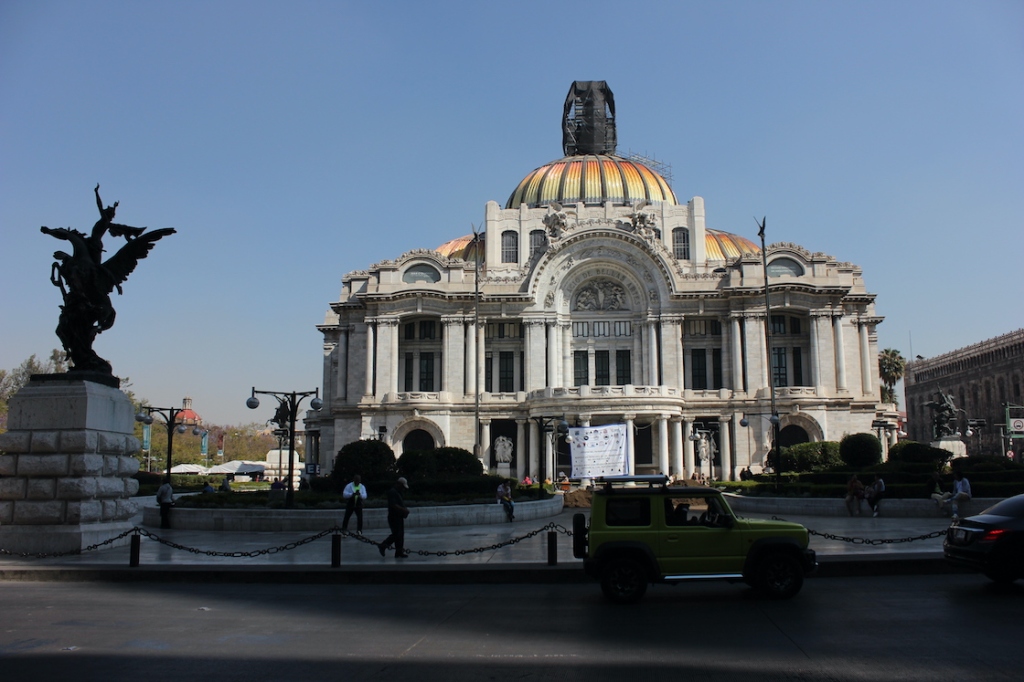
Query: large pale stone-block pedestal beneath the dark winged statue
0,377,139,553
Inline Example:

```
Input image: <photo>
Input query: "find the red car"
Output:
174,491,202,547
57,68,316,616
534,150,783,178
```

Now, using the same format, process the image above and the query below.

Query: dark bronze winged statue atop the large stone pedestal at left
40,184,175,377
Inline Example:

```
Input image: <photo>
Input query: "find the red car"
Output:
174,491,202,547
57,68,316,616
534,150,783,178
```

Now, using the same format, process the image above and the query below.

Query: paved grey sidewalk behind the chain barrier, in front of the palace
0,501,949,582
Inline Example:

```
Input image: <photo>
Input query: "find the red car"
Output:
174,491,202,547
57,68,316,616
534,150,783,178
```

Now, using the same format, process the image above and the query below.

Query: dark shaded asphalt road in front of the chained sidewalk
0,573,1024,682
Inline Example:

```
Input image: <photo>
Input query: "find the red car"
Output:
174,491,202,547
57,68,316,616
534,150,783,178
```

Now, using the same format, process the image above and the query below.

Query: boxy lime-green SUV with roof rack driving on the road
572,476,817,603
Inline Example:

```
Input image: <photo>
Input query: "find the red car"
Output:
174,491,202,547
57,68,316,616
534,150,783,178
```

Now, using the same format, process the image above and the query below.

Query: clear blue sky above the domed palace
0,0,1024,424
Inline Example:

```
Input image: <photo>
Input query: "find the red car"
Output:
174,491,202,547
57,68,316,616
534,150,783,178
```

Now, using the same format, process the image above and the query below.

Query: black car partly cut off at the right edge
942,495,1024,583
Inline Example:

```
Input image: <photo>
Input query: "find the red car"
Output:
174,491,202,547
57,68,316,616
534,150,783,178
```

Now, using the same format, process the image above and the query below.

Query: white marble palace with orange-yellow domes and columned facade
306,81,892,479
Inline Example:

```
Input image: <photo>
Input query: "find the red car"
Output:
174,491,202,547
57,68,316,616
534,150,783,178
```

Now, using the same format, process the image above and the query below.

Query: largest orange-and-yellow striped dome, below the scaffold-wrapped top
505,154,676,209
